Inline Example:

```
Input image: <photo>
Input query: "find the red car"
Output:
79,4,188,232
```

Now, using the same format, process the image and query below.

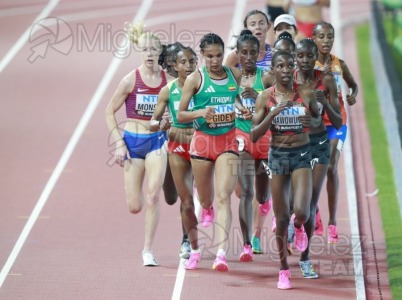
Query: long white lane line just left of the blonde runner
0,0,153,288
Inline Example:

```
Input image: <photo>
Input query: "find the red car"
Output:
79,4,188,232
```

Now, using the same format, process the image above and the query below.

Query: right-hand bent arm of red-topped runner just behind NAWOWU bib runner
321,74,342,129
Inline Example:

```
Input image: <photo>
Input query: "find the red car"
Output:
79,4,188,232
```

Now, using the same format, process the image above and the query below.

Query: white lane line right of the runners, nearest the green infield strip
330,0,366,300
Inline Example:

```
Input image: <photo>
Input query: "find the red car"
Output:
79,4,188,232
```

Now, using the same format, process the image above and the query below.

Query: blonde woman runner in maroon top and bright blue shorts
106,24,167,266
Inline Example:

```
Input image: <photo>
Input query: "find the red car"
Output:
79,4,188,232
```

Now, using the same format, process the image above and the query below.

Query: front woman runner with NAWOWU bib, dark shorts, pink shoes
250,50,319,289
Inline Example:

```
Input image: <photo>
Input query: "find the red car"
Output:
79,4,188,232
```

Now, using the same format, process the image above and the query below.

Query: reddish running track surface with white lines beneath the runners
0,0,390,299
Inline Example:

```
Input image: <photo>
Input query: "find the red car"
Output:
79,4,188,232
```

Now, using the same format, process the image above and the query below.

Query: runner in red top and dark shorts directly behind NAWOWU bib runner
293,39,342,278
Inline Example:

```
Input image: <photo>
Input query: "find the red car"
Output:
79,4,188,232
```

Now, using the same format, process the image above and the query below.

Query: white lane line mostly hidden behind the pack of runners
172,0,247,300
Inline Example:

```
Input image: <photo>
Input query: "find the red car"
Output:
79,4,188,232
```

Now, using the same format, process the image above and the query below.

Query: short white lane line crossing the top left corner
0,0,60,73
